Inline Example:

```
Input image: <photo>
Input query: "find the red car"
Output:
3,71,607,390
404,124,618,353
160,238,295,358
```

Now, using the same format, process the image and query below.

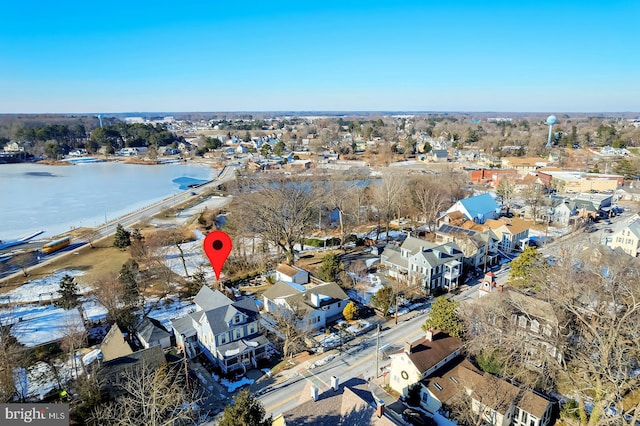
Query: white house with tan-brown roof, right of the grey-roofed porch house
262,281,349,331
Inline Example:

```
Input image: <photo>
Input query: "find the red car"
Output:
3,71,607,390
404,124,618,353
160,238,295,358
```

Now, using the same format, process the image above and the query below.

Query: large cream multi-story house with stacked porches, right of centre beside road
380,237,464,294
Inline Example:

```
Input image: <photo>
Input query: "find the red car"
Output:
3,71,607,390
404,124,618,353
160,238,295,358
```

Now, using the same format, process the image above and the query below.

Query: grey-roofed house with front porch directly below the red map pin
171,286,271,374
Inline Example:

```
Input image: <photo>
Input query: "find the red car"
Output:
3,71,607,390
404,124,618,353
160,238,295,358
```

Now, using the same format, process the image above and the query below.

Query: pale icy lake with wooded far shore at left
0,163,216,240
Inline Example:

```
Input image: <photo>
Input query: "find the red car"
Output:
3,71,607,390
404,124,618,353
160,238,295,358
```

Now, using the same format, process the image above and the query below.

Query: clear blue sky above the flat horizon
0,0,640,113
